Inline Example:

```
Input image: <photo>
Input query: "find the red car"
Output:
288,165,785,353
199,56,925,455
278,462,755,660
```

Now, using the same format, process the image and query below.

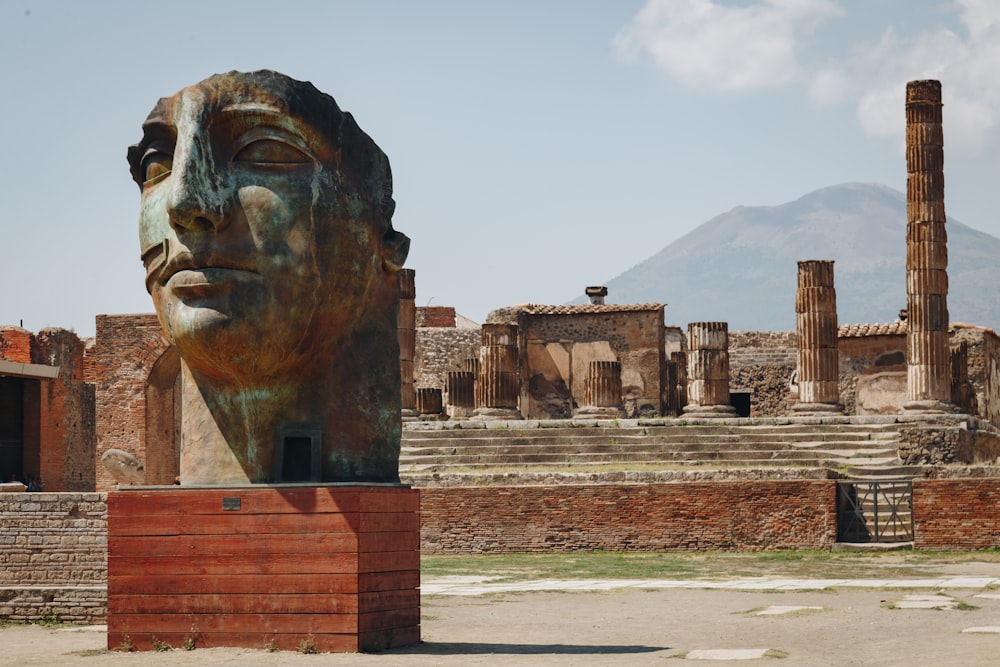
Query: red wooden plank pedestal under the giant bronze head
108,486,420,652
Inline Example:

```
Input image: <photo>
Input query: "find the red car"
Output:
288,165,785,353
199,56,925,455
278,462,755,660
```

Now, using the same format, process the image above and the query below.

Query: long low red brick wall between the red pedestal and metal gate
420,480,836,553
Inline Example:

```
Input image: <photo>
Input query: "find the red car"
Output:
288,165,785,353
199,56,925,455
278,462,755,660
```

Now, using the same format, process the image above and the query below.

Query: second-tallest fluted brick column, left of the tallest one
792,260,844,414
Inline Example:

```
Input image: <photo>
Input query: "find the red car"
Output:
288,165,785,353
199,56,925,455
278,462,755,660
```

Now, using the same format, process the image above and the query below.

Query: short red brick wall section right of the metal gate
913,477,1000,550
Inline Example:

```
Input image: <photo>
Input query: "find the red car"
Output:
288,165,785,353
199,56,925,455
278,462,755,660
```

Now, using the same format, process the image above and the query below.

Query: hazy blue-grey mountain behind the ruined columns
577,183,1000,331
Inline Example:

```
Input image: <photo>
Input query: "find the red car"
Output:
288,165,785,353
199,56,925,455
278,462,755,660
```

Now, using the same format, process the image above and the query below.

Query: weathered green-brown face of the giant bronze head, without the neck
130,73,392,384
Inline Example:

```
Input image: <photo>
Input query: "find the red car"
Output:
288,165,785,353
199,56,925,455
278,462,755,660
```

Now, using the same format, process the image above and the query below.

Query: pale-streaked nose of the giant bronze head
167,126,224,233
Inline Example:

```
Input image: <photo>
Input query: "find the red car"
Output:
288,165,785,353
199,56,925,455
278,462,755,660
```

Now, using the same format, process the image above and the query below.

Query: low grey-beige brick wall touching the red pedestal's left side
0,493,107,623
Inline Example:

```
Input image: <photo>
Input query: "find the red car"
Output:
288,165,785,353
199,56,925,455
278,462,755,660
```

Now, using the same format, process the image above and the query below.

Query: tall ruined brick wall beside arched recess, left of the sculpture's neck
85,315,168,491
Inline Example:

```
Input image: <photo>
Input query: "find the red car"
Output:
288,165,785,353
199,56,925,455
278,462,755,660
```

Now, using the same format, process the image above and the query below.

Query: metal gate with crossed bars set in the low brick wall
837,479,913,542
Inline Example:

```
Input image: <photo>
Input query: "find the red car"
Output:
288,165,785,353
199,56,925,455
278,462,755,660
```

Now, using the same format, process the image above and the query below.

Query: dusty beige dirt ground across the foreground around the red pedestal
0,580,1000,667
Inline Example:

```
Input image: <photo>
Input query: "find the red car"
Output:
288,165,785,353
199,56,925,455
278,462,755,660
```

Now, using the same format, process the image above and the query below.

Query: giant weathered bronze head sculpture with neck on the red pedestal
128,71,409,484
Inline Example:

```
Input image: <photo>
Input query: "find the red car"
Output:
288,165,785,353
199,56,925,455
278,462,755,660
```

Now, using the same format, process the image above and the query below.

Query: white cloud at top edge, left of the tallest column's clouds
614,0,840,91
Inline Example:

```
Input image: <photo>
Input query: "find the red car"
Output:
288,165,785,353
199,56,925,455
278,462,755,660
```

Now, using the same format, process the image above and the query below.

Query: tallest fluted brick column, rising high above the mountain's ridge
903,80,954,412
